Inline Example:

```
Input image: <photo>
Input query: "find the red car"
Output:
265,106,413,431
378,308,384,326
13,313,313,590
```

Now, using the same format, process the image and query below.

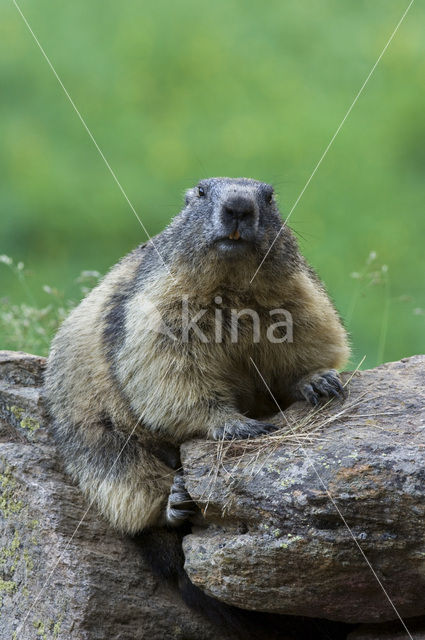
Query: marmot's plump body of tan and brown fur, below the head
45,183,349,534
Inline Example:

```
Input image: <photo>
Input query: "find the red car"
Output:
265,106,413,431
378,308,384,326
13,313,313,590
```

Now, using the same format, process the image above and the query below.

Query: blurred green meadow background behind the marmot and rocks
0,0,425,367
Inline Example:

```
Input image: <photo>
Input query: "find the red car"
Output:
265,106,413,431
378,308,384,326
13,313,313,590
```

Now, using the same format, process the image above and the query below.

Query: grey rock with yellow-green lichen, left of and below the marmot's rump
0,351,229,640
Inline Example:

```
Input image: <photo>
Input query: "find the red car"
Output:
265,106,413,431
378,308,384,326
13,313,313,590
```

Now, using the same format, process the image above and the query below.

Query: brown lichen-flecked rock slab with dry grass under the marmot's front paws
182,356,425,624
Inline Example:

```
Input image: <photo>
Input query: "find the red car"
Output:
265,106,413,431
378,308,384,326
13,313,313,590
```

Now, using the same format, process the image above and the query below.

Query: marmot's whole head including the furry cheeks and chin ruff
159,178,301,282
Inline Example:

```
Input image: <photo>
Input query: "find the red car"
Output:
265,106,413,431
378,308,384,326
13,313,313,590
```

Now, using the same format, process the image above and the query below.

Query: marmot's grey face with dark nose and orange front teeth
178,178,290,259
